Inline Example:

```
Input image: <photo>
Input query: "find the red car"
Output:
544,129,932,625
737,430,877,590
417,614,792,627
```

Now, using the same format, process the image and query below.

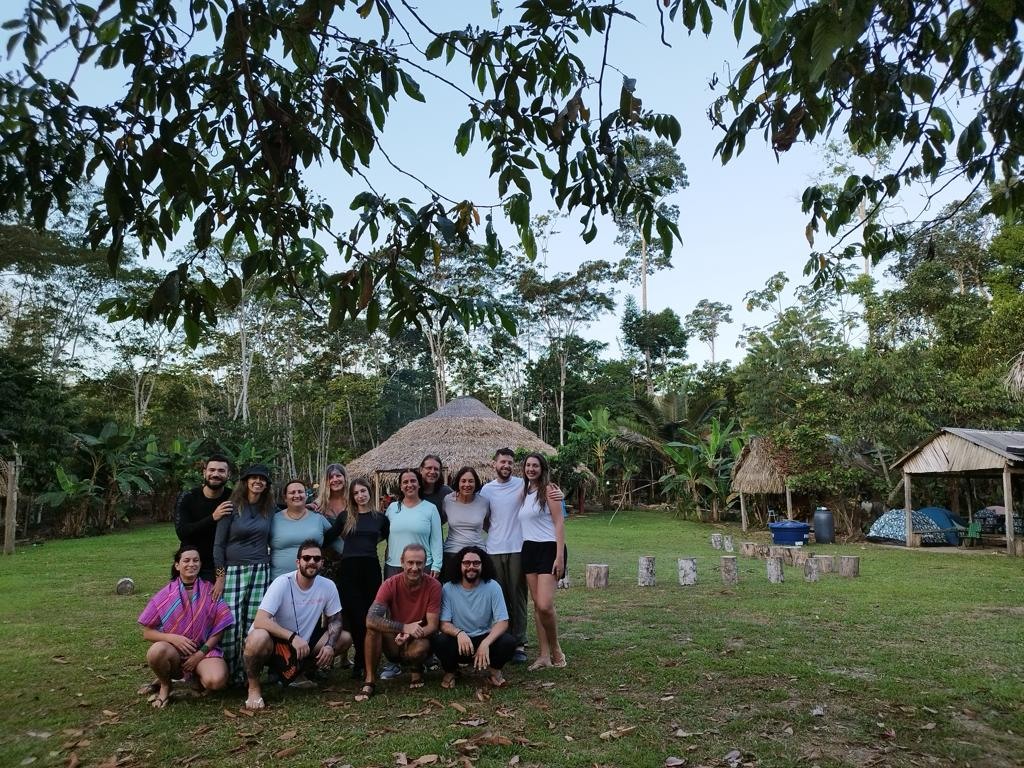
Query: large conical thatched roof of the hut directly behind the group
348,397,556,481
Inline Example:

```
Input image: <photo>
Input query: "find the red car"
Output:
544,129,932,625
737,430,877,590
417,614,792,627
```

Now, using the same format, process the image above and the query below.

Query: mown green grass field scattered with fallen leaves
0,512,1024,768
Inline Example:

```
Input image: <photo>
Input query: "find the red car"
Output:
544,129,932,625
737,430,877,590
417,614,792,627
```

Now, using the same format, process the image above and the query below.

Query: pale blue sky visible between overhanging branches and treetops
14,0,966,364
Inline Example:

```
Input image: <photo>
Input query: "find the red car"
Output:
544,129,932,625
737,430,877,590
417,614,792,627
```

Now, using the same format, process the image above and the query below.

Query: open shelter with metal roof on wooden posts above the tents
893,427,1024,555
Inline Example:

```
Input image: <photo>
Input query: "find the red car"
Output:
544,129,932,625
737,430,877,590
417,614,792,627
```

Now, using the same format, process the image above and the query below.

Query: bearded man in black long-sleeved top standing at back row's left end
174,454,231,583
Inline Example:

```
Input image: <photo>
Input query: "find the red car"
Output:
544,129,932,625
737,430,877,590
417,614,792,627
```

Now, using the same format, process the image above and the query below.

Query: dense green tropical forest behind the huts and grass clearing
6,190,1024,535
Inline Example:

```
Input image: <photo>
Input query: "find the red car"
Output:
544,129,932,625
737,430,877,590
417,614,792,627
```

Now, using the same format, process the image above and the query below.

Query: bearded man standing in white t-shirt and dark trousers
480,447,564,664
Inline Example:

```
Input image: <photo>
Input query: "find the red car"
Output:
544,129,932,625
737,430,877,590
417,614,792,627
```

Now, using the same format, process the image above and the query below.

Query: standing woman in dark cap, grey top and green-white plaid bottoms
213,464,275,685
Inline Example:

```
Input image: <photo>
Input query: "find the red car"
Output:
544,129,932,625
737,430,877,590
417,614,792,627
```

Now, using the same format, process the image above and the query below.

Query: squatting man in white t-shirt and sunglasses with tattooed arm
245,539,352,710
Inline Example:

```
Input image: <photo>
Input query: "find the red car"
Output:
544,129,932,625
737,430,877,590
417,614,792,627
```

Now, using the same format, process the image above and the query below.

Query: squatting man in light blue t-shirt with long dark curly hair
431,547,515,688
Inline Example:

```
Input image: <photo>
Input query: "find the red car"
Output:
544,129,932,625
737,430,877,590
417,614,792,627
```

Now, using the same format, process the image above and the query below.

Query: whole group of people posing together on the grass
138,449,566,710
